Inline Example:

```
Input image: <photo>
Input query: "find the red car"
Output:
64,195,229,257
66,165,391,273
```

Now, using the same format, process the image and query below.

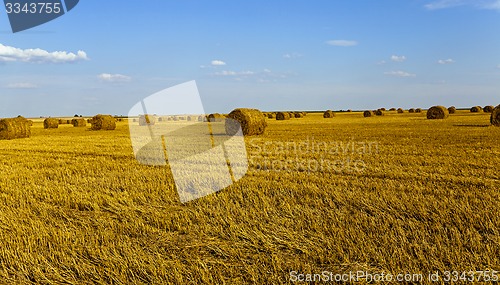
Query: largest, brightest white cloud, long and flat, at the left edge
0,44,88,63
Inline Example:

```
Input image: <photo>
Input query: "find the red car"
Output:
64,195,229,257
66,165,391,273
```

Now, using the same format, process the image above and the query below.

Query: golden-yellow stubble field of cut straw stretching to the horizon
0,111,500,284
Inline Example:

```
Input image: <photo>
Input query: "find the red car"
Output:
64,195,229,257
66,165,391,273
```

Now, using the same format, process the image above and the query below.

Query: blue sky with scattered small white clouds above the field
0,0,500,117
